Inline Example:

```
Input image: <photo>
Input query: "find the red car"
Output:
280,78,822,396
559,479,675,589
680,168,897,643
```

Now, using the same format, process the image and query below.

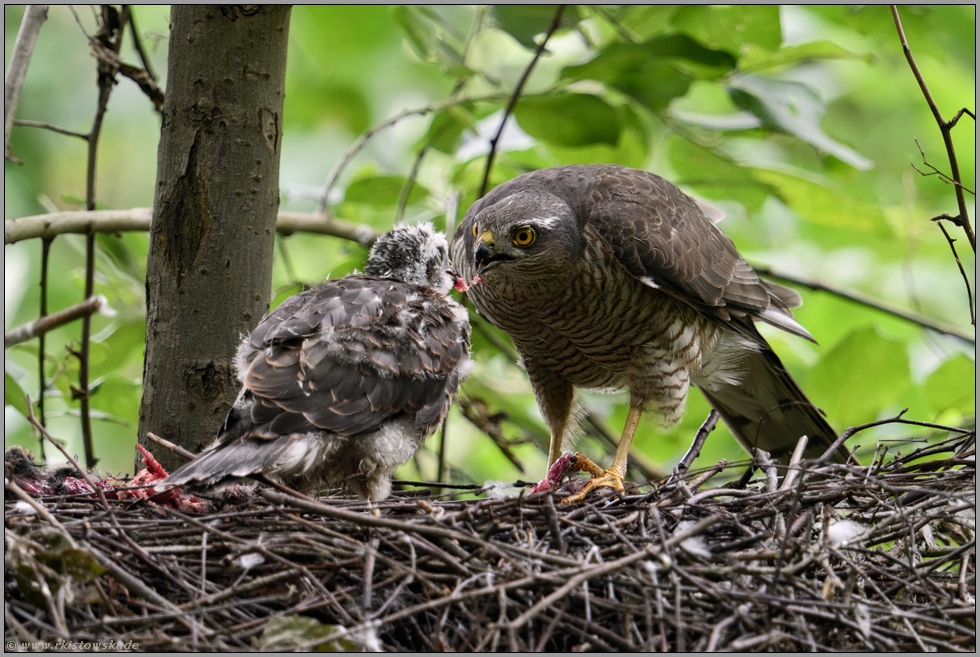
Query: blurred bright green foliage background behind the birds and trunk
4,6,976,482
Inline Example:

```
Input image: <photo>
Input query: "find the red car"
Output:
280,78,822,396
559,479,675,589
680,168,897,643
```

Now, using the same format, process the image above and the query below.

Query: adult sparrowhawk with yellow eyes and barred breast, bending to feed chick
452,165,844,501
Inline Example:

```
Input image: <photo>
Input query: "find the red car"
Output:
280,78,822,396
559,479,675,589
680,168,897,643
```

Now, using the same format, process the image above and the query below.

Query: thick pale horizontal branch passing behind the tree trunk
3,208,379,246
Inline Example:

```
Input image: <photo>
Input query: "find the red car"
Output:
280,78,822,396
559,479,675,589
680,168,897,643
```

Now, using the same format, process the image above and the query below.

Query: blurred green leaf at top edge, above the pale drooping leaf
673,5,782,55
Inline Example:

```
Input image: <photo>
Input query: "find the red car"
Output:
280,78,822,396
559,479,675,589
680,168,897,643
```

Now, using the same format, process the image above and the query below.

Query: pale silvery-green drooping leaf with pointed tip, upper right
729,75,874,171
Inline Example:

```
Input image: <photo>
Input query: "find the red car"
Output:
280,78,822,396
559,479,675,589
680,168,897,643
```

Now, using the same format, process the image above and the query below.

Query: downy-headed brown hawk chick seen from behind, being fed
161,224,472,502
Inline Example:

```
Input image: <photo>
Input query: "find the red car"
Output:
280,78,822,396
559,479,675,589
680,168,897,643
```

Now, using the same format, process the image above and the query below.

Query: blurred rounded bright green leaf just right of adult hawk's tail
806,327,911,427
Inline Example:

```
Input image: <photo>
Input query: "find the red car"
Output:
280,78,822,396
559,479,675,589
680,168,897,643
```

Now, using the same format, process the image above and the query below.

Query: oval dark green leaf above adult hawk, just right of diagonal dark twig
514,94,619,147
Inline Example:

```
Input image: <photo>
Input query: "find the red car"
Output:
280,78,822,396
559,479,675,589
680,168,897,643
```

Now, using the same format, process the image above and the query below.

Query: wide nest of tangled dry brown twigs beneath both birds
4,432,976,651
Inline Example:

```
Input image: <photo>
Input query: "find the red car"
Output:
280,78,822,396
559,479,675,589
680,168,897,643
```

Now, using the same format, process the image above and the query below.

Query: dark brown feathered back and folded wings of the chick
239,276,469,437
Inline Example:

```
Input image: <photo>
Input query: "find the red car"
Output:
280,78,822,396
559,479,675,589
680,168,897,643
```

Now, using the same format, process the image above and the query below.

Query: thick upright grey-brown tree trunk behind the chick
139,5,290,469
